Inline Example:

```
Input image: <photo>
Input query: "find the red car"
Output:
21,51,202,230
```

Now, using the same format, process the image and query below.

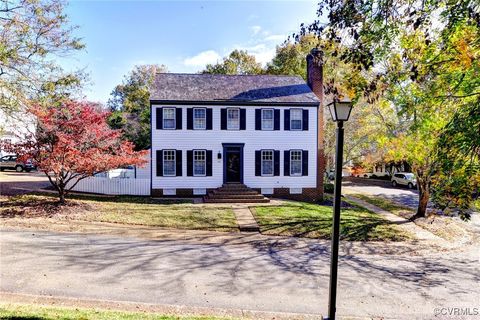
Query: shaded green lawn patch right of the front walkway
251,202,411,241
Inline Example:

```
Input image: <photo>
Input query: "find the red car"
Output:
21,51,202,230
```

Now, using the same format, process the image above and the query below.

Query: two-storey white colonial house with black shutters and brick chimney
150,50,324,201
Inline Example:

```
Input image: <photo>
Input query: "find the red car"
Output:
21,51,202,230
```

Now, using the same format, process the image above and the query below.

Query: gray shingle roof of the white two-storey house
150,73,319,104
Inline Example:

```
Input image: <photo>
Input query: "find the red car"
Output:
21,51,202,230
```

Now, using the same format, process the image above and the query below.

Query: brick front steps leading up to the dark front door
203,183,270,203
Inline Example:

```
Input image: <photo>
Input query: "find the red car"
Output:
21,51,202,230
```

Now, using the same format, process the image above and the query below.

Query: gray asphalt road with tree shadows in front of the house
0,230,480,319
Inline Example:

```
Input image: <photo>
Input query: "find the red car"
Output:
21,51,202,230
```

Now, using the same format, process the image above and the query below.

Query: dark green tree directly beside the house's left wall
108,65,167,150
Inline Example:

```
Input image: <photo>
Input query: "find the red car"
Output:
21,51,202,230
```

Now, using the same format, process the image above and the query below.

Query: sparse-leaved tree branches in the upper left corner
0,0,84,114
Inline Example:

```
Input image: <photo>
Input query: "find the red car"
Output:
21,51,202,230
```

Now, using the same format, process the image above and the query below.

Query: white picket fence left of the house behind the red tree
68,177,150,196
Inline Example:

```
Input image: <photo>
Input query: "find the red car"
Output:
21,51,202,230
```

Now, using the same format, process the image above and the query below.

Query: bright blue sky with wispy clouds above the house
62,1,316,103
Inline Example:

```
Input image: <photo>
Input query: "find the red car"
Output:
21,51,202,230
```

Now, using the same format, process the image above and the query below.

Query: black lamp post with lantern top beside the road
327,100,353,320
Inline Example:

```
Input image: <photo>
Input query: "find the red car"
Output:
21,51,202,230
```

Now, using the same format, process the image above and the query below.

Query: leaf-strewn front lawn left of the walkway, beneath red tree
0,195,238,231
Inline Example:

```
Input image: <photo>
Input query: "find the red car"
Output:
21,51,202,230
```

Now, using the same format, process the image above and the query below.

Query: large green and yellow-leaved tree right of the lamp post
297,0,480,217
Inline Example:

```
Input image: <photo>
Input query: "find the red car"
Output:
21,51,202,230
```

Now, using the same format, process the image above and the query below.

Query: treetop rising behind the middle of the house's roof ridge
202,50,263,74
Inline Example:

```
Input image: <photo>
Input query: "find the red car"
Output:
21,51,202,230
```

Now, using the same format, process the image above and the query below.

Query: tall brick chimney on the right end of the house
307,48,325,200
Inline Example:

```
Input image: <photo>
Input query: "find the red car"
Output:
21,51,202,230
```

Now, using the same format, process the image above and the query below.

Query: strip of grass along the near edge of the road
0,304,232,320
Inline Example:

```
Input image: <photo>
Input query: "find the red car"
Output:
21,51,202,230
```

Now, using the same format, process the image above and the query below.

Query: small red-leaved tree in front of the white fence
6,101,148,204
